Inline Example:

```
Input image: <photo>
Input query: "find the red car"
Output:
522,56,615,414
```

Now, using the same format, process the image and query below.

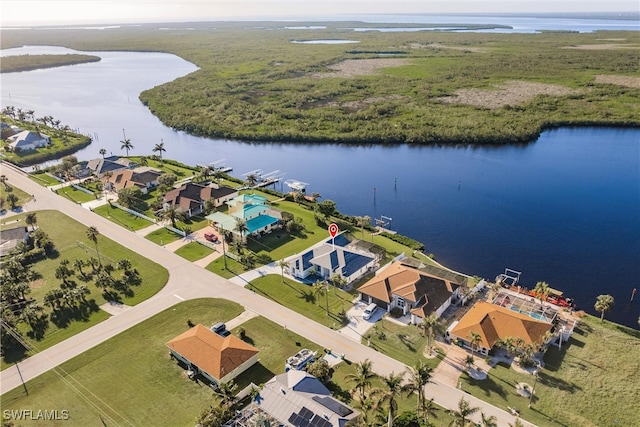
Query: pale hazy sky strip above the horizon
0,0,640,26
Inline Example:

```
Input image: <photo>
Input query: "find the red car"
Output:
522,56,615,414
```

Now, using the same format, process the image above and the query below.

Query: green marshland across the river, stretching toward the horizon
2,22,640,144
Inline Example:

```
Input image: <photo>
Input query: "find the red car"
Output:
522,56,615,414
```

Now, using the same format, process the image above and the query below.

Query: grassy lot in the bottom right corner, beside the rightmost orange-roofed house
463,315,640,426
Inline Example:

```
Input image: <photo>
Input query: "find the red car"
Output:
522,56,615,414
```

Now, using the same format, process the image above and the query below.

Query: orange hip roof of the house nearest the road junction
166,325,259,379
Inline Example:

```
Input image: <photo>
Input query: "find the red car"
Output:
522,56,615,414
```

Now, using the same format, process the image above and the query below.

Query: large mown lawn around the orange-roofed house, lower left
2,299,242,426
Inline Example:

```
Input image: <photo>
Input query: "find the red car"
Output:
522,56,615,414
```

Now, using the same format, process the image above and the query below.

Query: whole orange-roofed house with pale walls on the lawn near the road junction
166,325,259,386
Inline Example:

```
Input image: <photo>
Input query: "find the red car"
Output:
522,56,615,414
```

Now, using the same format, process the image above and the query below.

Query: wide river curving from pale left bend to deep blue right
1,36,640,328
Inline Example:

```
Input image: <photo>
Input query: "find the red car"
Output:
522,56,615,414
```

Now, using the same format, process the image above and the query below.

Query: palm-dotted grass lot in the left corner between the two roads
1,211,169,369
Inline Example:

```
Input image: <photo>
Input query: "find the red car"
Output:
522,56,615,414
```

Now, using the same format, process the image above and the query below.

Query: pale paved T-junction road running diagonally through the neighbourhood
0,163,529,425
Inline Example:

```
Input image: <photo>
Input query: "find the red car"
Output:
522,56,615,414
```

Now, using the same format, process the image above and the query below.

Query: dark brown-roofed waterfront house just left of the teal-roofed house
162,182,238,217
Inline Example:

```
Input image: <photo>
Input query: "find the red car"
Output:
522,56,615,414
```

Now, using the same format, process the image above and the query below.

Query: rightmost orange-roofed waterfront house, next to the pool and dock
445,301,553,356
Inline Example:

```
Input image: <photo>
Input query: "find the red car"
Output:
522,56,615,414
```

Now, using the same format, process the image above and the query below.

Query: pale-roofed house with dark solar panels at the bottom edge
254,369,360,427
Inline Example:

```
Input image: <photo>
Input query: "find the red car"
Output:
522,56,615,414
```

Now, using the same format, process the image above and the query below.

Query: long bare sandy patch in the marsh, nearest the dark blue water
438,81,577,109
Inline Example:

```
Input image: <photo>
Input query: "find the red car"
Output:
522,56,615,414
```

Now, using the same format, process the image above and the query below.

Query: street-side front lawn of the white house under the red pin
246,274,353,329
